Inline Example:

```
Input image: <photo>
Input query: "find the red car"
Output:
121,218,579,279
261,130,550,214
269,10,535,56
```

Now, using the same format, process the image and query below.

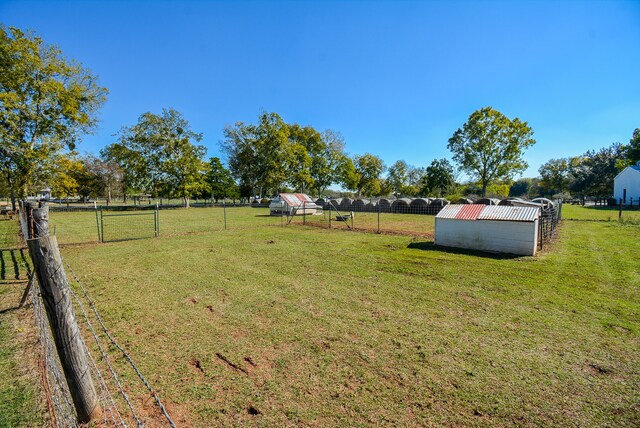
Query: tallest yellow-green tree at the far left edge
0,26,107,209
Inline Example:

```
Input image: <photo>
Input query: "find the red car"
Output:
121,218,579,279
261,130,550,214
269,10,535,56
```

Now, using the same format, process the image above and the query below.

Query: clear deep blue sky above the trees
0,1,640,176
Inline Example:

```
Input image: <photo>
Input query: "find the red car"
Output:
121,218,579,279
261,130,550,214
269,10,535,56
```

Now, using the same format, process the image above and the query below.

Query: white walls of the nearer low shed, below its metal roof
435,218,538,256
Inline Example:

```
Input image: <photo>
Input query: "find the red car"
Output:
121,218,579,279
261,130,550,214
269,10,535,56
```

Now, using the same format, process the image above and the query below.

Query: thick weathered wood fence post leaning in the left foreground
27,204,102,423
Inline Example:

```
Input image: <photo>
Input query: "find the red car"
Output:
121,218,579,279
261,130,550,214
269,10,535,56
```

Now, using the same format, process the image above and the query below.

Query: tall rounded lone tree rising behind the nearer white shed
447,107,535,196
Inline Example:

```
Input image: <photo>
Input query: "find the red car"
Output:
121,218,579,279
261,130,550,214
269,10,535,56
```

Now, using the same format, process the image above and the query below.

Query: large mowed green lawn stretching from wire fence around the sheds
45,207,640,426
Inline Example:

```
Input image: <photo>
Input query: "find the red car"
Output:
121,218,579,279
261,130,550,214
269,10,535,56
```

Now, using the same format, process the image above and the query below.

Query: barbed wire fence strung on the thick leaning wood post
19,204,176,427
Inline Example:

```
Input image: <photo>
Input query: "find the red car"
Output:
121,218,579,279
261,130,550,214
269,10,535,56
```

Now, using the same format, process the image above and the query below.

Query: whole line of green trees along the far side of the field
0,27,640,206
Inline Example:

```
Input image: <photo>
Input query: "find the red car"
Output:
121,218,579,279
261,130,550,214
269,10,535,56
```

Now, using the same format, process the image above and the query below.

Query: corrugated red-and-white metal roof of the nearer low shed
436,204,540,222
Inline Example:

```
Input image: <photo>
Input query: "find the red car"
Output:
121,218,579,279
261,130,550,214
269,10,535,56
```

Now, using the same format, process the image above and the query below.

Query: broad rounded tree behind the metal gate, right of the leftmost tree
103,109,207,208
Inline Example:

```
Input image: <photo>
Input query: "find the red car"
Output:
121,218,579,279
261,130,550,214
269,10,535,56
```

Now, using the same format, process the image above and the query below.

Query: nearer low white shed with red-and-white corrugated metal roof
435,204,540,256
